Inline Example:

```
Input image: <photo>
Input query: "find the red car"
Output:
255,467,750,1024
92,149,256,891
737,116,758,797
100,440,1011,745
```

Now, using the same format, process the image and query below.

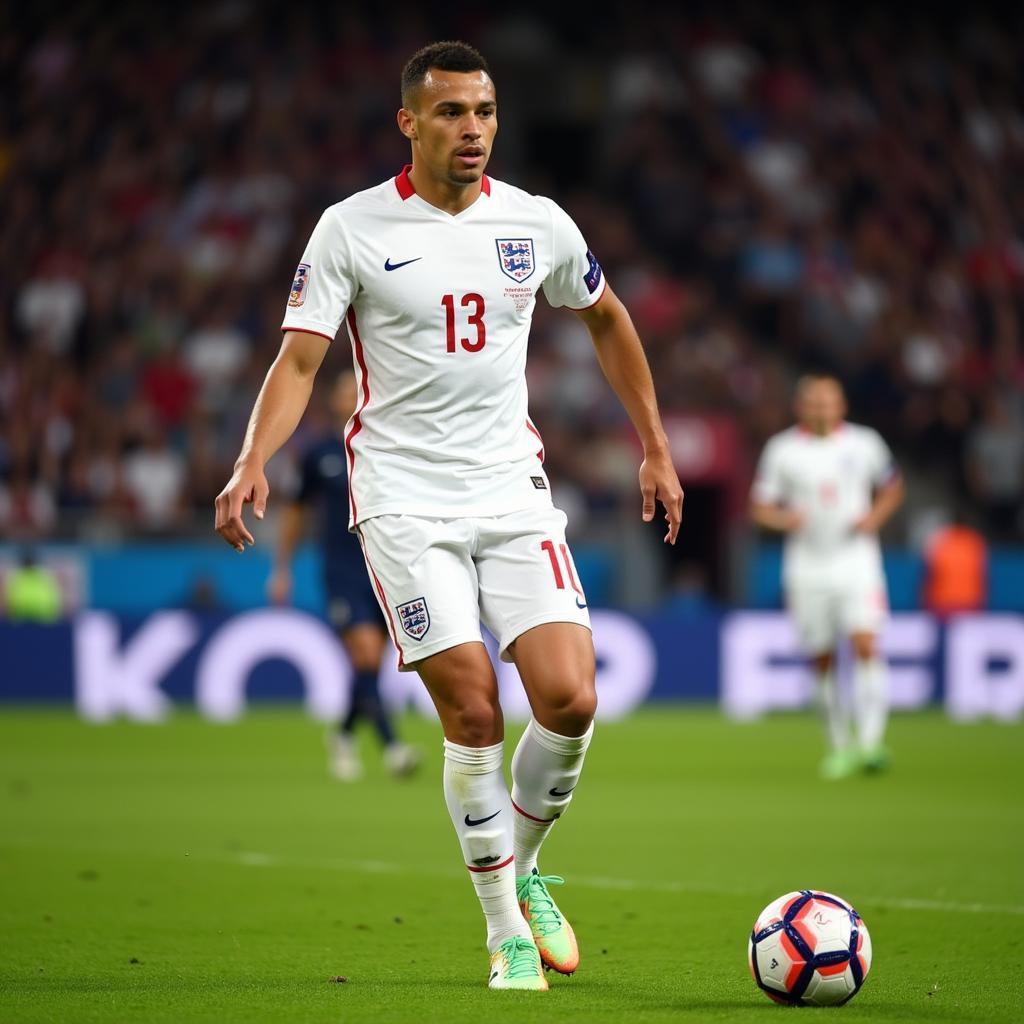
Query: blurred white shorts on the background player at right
785,573,889,655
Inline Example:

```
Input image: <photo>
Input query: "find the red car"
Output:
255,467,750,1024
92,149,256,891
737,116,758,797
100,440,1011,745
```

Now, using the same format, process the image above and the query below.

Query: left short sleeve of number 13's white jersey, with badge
281,207,356,339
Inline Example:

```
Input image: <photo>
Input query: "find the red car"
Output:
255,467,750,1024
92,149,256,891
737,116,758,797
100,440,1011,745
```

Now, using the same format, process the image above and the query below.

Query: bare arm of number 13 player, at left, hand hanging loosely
214,331,329,551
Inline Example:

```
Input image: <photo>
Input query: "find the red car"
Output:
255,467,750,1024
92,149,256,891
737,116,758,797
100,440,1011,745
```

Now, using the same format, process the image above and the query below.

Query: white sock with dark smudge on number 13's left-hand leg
444,739,530,952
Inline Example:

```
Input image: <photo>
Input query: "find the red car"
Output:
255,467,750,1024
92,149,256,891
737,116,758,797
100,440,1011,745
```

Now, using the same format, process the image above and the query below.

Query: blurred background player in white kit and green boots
751,376,903,778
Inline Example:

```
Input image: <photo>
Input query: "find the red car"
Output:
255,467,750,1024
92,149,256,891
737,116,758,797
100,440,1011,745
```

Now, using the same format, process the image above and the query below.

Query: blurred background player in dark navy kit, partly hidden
267,370,420,782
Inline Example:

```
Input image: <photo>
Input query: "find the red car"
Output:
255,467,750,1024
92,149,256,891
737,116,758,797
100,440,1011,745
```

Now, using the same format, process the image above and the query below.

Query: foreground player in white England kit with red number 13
216,43,683,989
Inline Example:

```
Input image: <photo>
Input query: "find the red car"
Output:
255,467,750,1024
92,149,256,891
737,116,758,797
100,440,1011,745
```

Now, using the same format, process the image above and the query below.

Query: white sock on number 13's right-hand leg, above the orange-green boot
512,718,594,874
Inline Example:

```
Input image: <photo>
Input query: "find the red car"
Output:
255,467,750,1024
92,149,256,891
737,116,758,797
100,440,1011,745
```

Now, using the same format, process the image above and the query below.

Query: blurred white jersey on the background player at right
753,423,897,588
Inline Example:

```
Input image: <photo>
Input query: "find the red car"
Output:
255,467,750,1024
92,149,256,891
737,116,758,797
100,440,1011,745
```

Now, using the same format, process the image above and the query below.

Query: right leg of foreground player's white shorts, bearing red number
475,508,590,662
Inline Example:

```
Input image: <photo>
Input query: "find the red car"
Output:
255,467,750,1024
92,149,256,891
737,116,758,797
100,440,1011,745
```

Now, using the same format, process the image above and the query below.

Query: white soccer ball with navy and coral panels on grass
748,889,871,1007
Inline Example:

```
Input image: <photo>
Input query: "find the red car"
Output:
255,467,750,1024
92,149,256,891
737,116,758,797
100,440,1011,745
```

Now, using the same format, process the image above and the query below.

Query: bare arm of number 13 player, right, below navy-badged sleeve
575,288,683,544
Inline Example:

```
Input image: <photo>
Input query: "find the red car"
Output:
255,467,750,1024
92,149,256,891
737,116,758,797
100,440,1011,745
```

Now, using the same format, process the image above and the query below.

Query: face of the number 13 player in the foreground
398,69,498,185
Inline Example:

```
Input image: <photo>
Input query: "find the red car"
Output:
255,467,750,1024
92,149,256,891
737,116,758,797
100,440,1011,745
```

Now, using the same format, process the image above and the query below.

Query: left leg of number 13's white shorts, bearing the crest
358,515,480,671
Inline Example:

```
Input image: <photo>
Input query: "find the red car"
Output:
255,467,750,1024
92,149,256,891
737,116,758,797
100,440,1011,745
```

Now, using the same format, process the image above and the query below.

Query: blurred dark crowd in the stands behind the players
0,0,1024,561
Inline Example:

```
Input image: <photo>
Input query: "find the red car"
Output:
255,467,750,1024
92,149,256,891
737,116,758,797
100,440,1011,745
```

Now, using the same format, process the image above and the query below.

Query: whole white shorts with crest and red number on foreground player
356,508,590,671
